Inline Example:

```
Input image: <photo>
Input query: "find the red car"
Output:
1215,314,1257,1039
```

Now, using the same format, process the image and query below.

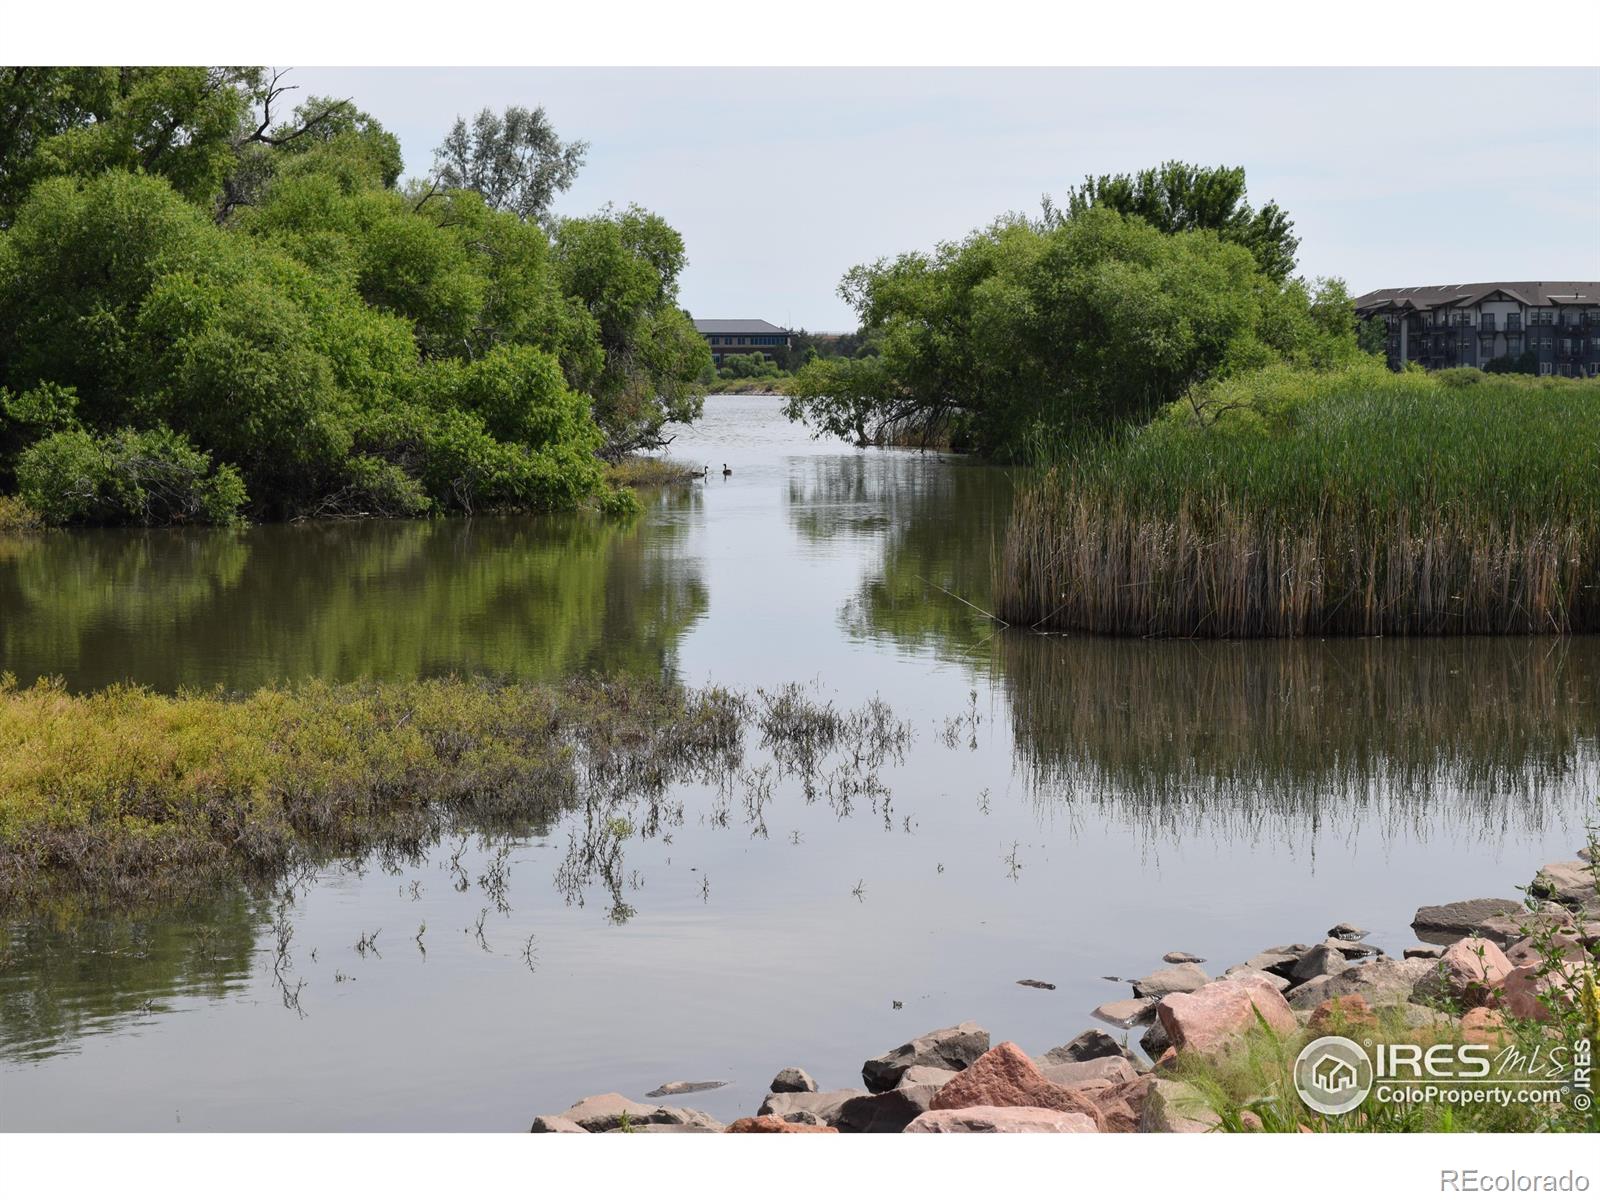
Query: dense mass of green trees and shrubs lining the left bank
0,67,710,525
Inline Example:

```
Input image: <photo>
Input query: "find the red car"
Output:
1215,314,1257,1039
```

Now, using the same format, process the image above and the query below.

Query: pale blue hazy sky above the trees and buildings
281,67,1600,330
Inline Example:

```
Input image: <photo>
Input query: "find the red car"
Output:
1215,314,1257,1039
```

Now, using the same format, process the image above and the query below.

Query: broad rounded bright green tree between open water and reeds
789,205,1355,459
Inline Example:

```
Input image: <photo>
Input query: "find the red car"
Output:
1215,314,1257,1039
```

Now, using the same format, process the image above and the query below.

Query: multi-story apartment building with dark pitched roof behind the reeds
1355,280,1600,376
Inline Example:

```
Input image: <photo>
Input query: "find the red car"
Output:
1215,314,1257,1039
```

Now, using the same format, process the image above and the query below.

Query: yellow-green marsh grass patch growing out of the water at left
0,677,742,899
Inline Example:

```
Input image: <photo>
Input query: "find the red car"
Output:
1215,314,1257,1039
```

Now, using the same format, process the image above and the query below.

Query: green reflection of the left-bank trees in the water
0,508,707,691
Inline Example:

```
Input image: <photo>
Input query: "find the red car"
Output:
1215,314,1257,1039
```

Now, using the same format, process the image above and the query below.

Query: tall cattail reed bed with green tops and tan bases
995,366,1600,637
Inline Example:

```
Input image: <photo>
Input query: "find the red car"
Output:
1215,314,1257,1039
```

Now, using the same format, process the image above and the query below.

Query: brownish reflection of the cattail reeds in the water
994,634,1600,842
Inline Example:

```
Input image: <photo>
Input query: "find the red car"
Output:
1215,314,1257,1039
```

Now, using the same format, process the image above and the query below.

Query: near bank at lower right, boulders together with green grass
530,844,1600,1133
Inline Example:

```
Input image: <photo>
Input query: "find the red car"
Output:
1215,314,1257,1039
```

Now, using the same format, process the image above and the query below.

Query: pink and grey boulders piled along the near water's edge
531,843,1600,1133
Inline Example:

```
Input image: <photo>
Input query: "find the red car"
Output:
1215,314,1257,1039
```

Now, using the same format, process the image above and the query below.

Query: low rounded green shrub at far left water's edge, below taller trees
16,427,246,525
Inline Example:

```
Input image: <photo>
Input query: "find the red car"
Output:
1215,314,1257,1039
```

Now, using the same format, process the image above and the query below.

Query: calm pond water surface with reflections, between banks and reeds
0,397,1600,1130
